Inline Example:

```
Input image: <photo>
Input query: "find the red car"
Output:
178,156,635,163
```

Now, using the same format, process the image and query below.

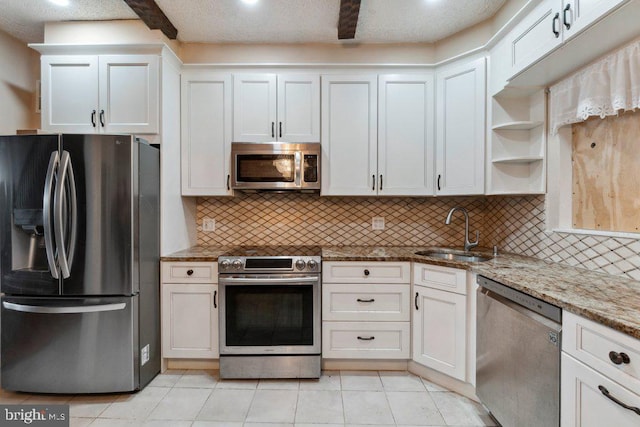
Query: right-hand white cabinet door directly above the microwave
276,74,320,142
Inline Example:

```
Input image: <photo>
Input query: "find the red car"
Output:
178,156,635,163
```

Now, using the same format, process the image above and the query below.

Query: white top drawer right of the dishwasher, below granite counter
562,311,640,396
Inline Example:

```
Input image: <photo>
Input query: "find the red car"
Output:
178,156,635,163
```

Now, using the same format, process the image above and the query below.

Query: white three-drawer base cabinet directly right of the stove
322,262,411,359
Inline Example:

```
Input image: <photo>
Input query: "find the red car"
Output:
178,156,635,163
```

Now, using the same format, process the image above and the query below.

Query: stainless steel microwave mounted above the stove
231,142,320,192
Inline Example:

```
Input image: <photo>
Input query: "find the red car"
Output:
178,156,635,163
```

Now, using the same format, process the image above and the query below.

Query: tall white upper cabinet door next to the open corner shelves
436,58,486,195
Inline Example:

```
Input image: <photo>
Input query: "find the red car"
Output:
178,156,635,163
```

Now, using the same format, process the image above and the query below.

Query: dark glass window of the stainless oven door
225,285,313,346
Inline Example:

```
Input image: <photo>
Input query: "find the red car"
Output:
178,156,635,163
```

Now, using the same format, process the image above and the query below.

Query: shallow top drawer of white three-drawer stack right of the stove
322,262,411,283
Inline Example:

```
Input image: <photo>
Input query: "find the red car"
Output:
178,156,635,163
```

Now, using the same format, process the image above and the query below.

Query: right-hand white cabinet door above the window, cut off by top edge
562,0,626,41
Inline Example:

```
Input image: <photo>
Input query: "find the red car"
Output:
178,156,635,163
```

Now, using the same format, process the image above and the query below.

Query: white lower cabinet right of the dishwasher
560,311,640,427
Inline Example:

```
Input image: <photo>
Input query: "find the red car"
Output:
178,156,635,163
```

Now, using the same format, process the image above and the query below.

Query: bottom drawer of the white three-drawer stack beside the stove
322,322,410,359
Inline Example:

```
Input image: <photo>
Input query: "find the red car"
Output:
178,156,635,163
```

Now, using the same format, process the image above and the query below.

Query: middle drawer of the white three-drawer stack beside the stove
322,283,410,322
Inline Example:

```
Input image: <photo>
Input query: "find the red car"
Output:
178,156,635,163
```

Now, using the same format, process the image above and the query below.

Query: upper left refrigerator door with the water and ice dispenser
0,135,60,296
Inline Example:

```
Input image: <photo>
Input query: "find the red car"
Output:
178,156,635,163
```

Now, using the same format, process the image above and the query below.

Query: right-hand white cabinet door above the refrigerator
99,55,160,133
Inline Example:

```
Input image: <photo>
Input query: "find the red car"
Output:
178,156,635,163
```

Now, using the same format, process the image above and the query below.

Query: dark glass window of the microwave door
236,154,296,182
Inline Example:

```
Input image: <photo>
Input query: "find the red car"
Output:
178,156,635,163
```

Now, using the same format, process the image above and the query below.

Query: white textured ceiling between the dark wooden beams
0,0,506,43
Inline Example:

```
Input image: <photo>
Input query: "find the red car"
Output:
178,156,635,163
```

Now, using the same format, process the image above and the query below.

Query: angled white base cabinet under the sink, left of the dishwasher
412,264,467,381
